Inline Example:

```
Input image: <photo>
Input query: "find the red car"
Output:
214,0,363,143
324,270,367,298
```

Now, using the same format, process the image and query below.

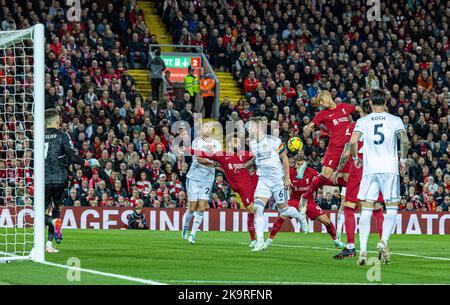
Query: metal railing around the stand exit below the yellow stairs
147,44,220,119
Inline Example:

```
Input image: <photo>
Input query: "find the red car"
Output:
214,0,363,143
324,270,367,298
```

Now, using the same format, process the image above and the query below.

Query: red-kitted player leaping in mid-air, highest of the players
301,90,362,206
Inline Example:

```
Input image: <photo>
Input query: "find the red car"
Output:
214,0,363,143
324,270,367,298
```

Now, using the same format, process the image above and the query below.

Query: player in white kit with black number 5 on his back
350,89,409,265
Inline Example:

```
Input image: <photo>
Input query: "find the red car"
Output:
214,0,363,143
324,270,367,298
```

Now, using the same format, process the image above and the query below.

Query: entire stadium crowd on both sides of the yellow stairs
0,0,450,211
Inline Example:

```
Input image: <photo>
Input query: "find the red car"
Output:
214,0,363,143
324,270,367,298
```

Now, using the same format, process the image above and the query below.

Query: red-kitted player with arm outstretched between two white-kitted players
185,135,258,248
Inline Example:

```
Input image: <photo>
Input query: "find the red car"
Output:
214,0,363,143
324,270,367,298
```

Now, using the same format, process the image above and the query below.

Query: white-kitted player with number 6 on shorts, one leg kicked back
239,118,307,251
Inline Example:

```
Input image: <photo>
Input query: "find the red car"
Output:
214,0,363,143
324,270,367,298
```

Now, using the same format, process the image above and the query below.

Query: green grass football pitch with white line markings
0,230,450,285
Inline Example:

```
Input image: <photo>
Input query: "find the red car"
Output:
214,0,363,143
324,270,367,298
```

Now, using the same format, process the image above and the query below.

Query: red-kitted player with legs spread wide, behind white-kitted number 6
265,154,345,248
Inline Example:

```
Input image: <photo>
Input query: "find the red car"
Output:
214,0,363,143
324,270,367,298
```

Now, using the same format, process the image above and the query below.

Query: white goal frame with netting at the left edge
0,24,45,262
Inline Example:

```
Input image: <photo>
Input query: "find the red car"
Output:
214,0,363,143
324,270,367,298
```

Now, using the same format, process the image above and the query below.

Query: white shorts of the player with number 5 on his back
358,173,400,203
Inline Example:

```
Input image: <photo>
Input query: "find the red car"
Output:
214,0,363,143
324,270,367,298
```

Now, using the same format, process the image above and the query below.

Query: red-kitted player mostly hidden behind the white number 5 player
331,102,384,259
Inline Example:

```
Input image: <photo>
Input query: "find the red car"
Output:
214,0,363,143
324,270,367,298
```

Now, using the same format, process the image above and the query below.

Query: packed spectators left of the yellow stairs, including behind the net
0,0,238,208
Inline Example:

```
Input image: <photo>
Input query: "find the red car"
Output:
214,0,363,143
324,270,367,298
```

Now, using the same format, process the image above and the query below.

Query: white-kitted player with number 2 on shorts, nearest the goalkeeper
182,122,222,244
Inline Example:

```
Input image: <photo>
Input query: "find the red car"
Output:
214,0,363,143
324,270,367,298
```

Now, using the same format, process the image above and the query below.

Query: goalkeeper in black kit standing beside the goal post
44,108,100,253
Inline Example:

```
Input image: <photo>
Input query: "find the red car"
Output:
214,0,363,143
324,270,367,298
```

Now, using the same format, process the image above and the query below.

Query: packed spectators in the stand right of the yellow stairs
159,0,450,211
